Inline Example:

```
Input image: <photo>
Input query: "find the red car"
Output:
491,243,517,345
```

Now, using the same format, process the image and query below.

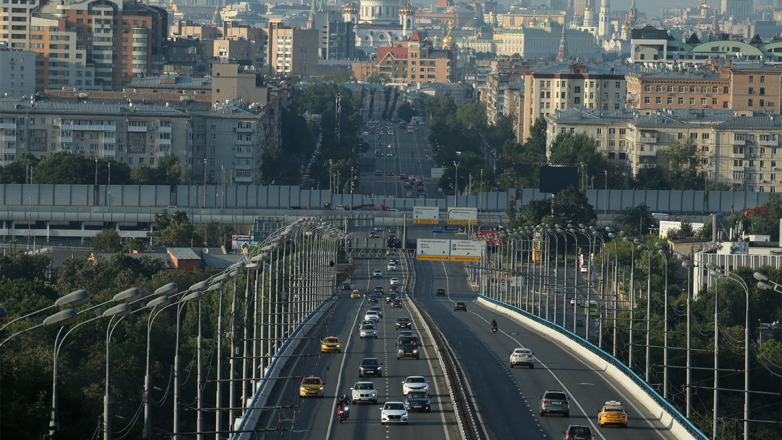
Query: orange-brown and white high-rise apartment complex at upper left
29,0,168,90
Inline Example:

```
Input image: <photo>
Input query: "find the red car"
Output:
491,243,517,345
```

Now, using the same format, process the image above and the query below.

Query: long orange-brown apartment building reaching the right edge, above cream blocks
627,63,782,112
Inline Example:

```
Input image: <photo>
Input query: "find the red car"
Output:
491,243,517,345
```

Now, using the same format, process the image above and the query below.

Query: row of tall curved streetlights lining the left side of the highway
0,219,344,440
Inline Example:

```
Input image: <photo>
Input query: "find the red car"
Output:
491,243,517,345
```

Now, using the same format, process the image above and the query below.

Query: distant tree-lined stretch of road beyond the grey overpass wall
357,122,443,198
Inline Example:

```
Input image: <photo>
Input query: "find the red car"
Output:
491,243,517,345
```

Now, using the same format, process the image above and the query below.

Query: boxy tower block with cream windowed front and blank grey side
268,23,318,79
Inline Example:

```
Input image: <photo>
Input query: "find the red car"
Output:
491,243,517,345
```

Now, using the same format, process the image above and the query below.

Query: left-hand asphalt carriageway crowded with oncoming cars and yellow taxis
248,254,459,440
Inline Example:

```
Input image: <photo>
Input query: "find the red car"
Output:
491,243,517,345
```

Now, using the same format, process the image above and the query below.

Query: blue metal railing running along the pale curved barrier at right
478,294,709,440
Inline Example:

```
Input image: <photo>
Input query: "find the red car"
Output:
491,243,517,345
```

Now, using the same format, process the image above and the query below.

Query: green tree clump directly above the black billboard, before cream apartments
549,133,620,188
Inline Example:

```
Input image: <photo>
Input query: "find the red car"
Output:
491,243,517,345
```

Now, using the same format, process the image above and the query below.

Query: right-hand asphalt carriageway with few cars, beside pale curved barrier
415,261,675,440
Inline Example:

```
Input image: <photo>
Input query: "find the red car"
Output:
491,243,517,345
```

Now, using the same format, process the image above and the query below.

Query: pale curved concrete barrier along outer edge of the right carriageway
478,295,708,440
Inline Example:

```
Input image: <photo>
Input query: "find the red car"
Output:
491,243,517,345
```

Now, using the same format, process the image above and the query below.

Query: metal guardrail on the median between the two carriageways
402,252,481,440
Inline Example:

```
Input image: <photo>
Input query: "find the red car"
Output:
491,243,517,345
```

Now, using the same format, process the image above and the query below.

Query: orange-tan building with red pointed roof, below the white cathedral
368,31,456,84
